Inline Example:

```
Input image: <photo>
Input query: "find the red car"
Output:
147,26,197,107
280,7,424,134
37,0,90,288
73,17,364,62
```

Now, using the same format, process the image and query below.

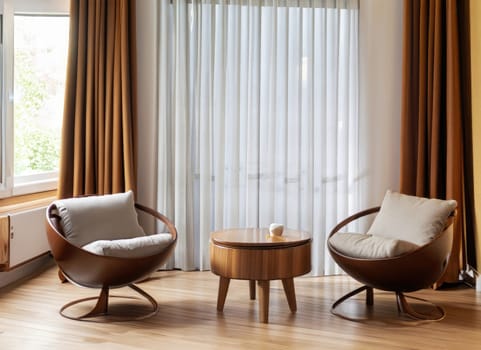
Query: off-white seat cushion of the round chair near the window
82,233,172,258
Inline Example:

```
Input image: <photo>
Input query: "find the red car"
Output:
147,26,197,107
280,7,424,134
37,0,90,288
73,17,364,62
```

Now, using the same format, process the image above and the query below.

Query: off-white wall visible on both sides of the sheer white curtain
133,0,403,211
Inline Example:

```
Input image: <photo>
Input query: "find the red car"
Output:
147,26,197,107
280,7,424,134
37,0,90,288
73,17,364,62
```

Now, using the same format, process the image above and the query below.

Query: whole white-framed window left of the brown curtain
0,0,69,197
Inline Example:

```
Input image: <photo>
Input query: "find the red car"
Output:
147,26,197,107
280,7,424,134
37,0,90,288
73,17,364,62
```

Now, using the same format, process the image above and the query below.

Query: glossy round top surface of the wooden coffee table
210,228,312,248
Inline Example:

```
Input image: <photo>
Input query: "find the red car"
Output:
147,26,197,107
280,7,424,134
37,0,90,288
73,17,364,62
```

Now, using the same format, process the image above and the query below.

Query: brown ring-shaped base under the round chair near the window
59,284,159,322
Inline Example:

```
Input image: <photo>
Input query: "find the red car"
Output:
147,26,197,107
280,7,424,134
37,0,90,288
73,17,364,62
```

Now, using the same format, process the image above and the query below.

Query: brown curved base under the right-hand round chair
331,286,446,321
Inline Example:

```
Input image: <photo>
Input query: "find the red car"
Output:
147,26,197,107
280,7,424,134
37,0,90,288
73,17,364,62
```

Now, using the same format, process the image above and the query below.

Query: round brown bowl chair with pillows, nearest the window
46,191,177,322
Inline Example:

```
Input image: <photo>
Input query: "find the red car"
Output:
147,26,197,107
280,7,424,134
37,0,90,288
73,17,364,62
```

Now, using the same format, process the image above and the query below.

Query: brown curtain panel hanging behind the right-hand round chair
400,0,470,286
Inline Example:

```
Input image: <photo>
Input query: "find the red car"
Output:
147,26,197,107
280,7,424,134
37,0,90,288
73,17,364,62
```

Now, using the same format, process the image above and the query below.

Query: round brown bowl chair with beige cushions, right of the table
327,191,457,320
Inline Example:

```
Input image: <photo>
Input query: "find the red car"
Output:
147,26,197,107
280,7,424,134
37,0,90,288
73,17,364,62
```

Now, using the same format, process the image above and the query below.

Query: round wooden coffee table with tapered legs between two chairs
210,228,312,323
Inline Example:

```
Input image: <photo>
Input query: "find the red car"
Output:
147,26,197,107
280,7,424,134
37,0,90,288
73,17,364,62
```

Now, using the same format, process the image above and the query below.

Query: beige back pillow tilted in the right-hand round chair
367,190,457,245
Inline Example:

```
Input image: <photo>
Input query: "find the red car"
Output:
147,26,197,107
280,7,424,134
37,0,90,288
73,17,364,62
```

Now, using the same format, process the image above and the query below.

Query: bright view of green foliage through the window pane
14,16,68,176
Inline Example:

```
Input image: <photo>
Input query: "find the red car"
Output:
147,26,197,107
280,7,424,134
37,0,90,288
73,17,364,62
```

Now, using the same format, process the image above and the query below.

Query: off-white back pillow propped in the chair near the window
55,191,145,247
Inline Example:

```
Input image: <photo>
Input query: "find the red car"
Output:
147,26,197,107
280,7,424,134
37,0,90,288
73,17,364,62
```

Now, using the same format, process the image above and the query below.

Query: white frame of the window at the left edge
0,0,69,198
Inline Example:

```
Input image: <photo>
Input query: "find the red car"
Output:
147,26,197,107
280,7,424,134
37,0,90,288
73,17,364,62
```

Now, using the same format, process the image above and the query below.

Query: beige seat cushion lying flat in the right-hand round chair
329,232,418,259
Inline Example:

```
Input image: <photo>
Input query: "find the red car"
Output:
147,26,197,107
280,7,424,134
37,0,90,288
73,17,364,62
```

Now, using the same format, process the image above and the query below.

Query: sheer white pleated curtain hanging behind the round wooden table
158,0,360,275
